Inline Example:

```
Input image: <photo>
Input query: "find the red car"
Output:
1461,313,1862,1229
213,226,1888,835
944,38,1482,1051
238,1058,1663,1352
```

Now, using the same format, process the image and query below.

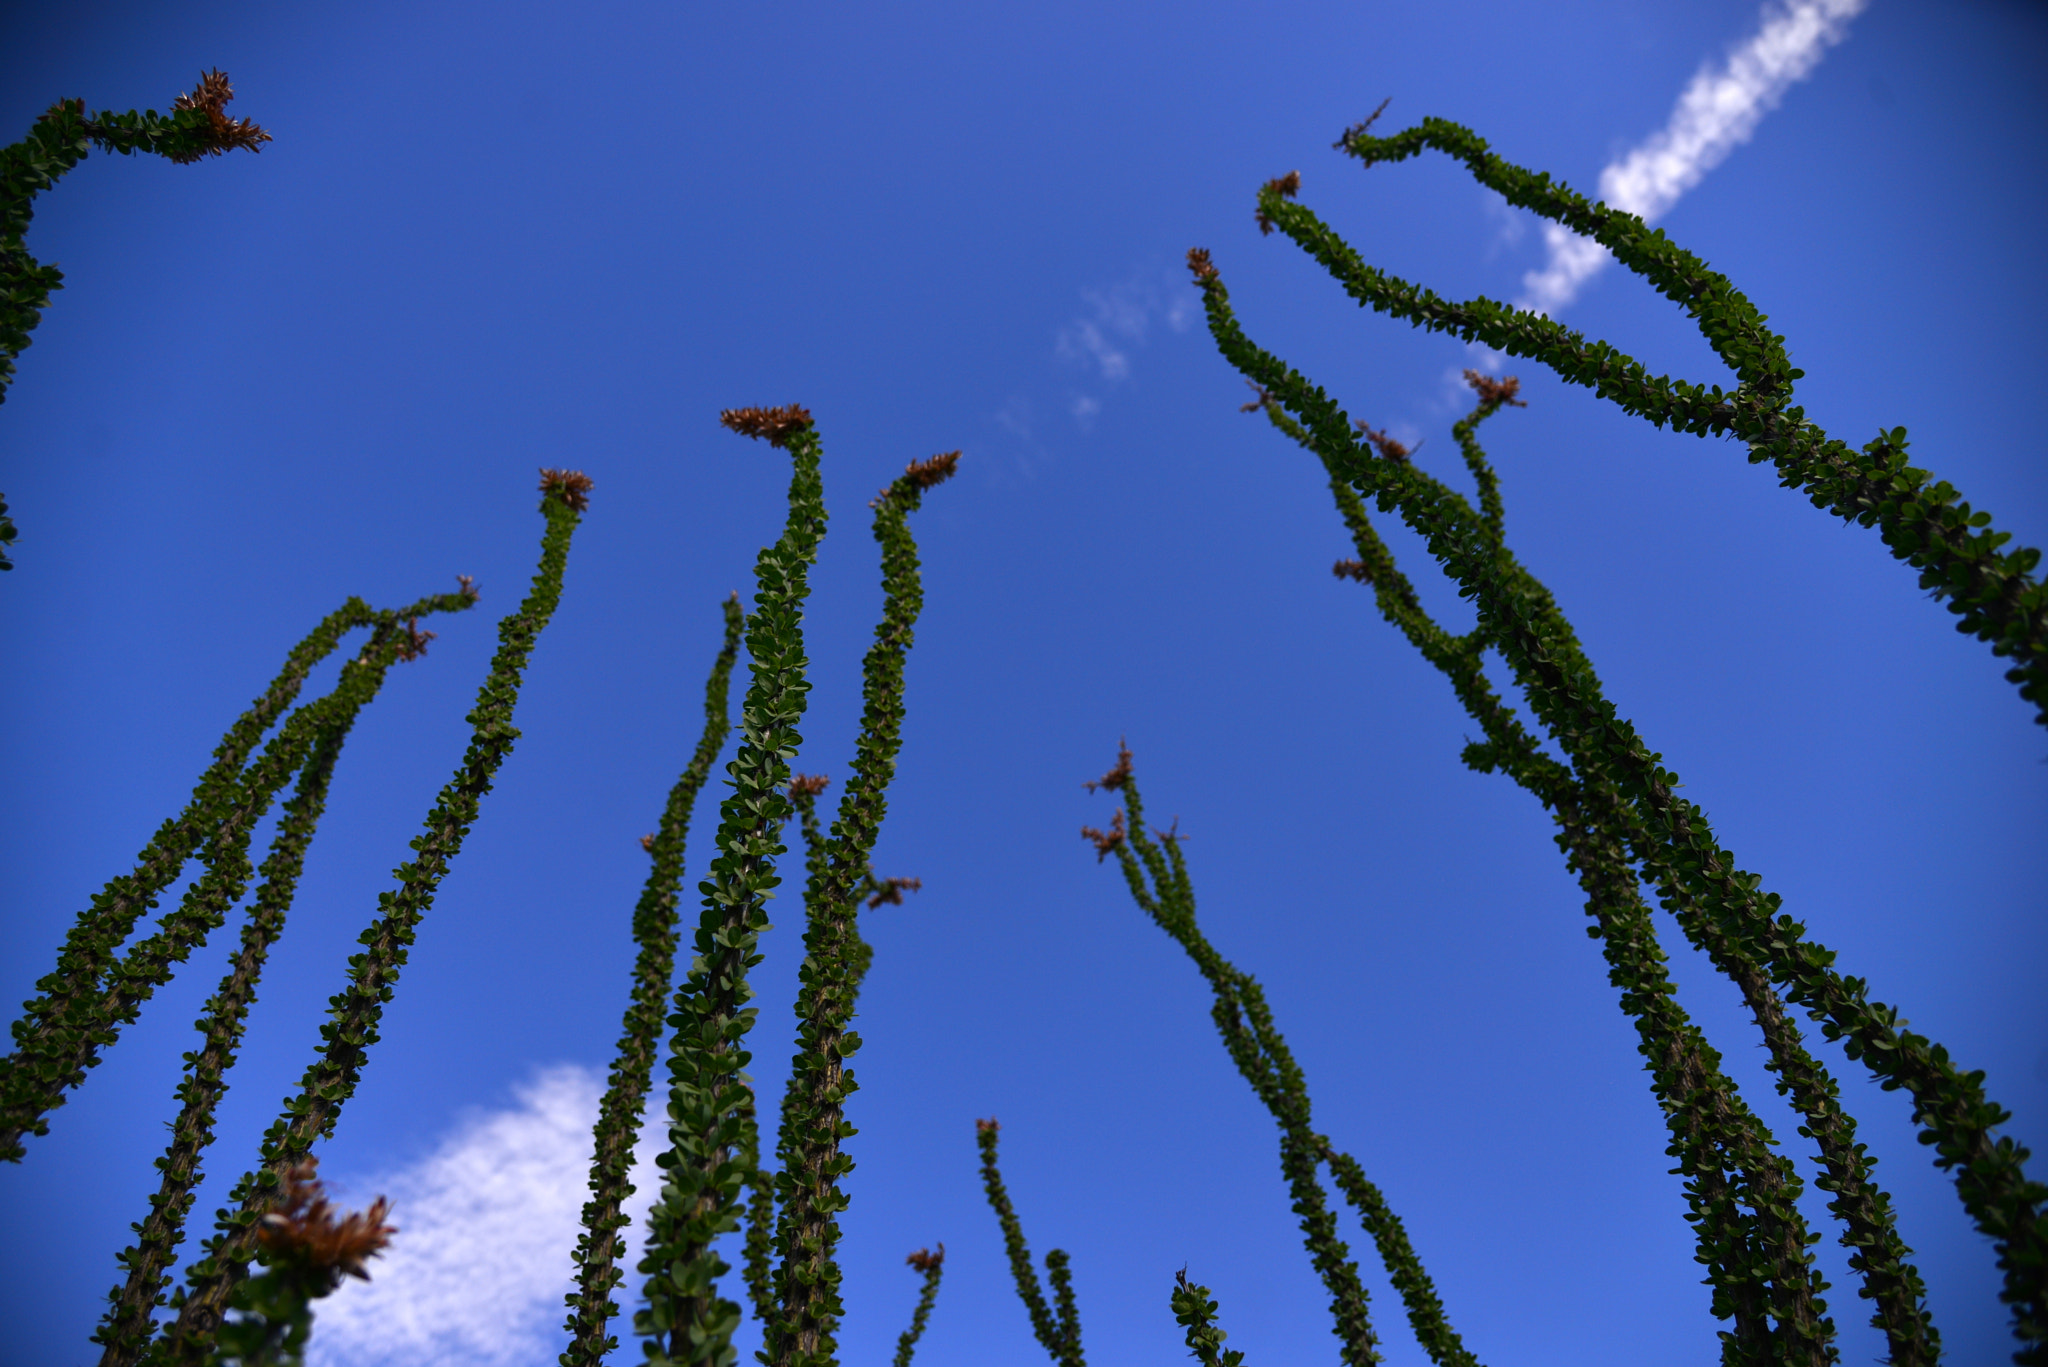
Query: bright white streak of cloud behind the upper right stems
1518,0,1866,314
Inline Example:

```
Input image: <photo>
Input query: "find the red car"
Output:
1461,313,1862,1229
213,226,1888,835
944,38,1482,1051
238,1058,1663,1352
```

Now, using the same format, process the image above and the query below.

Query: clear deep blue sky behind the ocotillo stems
0,0,2048,1367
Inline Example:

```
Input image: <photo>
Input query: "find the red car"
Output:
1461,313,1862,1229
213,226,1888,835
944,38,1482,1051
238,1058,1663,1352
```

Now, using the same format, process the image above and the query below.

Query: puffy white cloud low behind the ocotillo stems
309,1066,659,1367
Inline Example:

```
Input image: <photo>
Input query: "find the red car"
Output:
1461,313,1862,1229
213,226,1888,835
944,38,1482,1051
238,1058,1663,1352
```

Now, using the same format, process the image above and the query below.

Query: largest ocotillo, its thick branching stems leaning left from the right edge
1155,104,2048,1365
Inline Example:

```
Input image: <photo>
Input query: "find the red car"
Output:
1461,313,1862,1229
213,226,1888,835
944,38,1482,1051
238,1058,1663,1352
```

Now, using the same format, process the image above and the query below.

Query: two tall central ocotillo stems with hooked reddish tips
635,406,958,1367
